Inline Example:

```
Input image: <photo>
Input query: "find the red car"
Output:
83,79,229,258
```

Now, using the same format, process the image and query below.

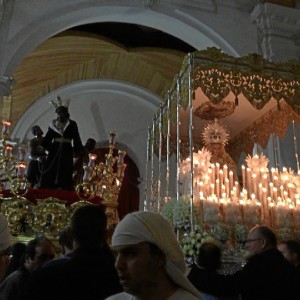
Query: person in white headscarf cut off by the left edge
0,214,11,282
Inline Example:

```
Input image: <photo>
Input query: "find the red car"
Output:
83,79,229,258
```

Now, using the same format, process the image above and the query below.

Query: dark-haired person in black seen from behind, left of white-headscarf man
21,204,123,300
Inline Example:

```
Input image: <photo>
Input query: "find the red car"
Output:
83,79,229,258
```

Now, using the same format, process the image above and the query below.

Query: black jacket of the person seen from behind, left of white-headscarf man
22,247,122,300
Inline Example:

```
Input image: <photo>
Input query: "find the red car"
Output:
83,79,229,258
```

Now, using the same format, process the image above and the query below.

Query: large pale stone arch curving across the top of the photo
3,3,237,74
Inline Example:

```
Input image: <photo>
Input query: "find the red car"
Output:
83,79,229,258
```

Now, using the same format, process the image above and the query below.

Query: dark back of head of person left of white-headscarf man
71,204,107,246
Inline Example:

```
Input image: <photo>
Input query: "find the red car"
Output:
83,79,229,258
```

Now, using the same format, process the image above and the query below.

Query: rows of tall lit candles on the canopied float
182,158,300,230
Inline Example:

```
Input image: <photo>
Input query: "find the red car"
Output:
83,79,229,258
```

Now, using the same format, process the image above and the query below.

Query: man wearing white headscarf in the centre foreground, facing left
107,211,203,300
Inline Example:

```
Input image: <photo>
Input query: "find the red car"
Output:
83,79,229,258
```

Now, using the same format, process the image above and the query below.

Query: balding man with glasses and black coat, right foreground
188,225,300,300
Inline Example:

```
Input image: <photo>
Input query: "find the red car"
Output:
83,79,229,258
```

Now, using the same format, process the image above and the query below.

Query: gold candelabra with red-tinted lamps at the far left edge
0,120,29,197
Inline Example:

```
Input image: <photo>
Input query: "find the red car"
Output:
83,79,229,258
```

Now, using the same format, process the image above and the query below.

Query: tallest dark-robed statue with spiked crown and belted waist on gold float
41,96,83,189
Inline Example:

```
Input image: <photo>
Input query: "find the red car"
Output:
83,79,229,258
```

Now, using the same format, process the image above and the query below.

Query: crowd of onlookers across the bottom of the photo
0,204,300,300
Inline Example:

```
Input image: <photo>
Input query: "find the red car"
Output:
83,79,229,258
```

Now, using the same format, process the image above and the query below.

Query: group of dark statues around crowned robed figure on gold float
26,96,96,190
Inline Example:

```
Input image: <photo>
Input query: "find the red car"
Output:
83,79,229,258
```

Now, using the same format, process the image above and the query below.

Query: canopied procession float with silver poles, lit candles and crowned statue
144,48,300,270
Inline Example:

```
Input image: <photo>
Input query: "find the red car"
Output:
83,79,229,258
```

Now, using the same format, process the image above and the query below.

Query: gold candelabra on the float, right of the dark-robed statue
76,132,126,227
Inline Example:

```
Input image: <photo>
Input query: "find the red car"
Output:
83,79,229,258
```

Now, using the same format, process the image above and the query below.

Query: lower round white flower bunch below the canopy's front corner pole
181,225,218,258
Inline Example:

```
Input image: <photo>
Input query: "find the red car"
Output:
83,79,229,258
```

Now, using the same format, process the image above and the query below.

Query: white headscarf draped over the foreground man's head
112,211,203,299
